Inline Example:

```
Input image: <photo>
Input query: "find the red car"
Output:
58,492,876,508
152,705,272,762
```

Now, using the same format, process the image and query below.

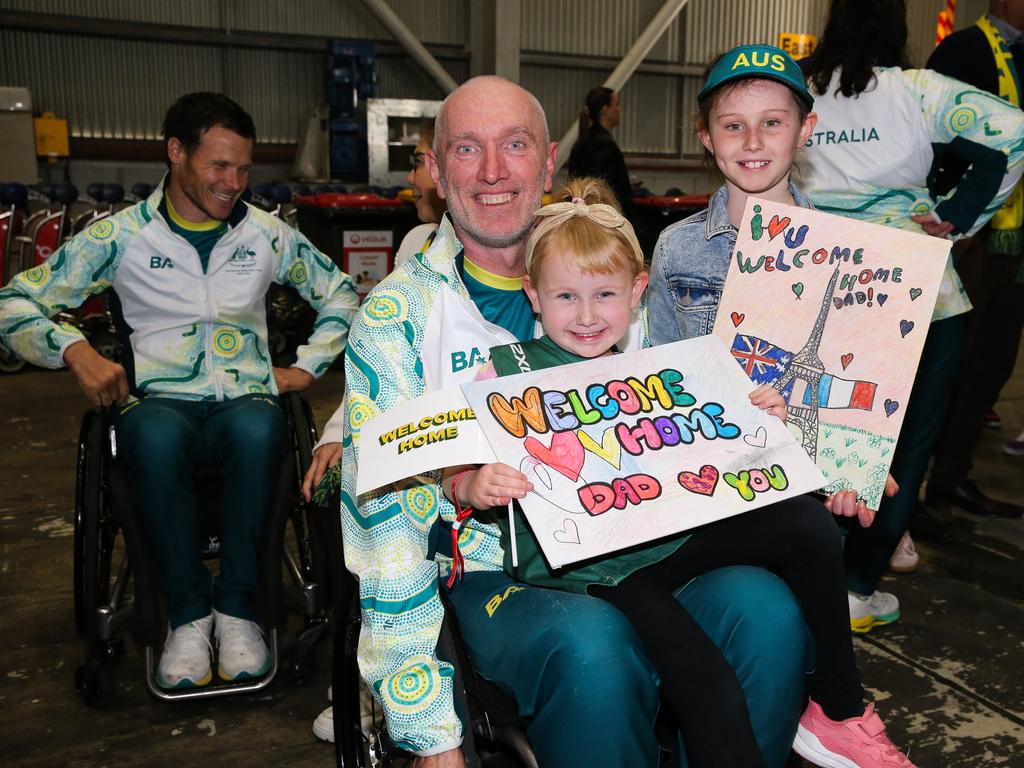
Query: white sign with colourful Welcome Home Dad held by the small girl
463,337,822,568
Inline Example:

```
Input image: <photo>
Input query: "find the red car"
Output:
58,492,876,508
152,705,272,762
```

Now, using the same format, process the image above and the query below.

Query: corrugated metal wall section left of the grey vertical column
0,0,469,142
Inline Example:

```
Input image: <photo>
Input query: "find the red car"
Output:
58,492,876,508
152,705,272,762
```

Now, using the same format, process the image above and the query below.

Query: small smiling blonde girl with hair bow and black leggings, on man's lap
442,174,910,768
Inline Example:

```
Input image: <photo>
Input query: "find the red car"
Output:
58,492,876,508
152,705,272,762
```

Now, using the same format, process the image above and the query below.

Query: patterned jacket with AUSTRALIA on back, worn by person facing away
796,68,1024,319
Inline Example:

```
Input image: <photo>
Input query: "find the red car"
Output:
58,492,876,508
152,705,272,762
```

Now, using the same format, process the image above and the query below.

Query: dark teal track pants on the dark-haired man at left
116,394,288,628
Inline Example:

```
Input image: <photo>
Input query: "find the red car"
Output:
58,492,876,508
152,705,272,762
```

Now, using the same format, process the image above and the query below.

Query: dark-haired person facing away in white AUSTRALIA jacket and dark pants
799,0,1024,632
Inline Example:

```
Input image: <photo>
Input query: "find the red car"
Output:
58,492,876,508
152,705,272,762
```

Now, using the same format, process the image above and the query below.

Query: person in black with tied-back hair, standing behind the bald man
568,86,633,218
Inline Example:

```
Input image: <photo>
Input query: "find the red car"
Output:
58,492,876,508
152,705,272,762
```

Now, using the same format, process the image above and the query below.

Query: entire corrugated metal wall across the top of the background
0,0,958,158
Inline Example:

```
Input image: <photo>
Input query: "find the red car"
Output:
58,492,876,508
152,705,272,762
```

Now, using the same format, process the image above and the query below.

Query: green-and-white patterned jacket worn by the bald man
341,216,643,755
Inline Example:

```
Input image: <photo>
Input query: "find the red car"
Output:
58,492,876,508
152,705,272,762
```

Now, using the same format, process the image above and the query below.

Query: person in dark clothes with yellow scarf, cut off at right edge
926,0,1024,519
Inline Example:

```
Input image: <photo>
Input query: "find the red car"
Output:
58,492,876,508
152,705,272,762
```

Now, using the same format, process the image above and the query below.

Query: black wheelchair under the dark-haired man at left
74,392,330,708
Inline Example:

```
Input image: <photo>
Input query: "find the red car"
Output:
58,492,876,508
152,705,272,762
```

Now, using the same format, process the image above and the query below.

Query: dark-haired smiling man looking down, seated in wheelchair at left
0,92,358,688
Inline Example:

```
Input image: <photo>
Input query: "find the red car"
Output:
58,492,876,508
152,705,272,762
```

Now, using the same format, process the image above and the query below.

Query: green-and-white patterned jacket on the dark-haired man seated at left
0,185,358,400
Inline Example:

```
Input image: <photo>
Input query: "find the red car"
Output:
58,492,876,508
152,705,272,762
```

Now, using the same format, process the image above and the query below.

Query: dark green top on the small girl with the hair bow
490,336,689,593
